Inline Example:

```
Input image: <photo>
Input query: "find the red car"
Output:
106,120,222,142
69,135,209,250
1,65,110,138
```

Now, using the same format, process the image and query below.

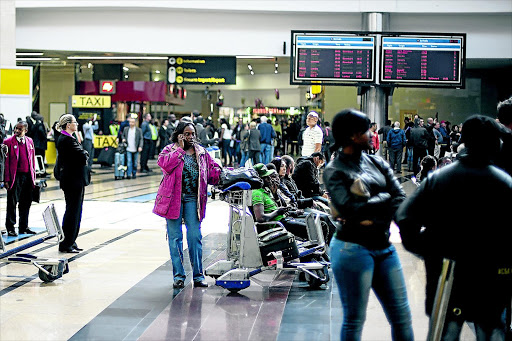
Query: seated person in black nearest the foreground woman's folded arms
292,152,329,205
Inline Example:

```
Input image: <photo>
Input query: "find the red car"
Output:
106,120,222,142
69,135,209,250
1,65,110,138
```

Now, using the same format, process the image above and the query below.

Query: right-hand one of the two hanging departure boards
379,34,465,87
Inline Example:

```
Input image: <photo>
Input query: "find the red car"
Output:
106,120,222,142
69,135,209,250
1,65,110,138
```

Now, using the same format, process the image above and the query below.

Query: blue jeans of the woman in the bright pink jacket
166,194,204,282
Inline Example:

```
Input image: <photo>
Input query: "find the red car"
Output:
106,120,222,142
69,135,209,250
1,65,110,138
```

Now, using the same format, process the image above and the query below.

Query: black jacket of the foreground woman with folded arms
324,152,405,249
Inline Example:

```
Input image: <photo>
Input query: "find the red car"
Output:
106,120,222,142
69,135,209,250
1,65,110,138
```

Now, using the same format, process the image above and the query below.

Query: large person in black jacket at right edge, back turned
395,115,512,340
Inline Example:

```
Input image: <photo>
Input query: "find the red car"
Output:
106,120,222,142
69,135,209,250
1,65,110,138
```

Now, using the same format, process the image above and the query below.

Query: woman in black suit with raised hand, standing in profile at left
55,114,90,253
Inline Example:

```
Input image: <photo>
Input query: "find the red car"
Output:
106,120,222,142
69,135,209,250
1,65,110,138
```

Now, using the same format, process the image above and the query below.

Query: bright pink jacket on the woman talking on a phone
153,143,221,221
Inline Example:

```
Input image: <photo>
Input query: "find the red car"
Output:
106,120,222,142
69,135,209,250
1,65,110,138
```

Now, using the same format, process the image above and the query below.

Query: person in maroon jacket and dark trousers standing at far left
4,121,36,236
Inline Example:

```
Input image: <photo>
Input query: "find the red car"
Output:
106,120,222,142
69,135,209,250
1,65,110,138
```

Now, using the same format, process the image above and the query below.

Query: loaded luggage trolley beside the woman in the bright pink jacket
205,182,330,292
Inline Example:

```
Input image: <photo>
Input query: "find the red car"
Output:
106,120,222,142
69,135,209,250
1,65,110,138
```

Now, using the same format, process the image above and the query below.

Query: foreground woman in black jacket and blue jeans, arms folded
324,109,414,340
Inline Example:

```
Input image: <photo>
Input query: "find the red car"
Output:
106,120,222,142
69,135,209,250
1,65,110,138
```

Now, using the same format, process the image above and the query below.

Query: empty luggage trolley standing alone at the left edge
0,204,69,283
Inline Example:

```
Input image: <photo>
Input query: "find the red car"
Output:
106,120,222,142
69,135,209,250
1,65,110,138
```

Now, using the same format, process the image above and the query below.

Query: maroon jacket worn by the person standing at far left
4,136,36,189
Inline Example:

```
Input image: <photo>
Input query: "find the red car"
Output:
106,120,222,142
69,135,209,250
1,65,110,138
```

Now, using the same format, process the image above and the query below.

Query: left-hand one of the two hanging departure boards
290,31,376,85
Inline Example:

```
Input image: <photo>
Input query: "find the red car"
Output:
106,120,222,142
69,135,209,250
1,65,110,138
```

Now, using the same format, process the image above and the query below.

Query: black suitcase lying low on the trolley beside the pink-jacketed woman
258,227,299,265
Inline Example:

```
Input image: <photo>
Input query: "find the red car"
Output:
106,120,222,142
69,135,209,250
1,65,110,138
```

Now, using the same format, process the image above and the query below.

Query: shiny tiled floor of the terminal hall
0,162,471,341
